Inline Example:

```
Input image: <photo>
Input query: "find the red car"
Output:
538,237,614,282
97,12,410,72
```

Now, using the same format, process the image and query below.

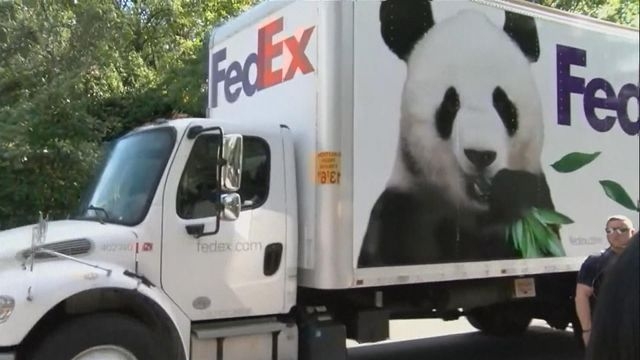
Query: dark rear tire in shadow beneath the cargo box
466,304,532,336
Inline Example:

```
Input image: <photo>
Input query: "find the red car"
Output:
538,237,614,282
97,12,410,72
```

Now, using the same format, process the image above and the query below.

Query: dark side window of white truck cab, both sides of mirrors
176,135,271,219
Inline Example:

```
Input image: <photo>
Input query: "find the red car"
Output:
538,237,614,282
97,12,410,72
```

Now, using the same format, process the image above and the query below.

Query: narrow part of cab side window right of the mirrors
238,136,271,210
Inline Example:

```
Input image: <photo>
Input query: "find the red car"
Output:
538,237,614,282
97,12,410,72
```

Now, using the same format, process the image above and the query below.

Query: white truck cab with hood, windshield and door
0,119,297,359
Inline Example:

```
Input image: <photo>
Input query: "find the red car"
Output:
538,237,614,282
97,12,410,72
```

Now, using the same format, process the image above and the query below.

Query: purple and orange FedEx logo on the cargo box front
209,18,315,108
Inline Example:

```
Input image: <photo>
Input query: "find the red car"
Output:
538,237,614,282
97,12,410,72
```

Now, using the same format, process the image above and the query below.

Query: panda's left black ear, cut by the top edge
380,0,434,61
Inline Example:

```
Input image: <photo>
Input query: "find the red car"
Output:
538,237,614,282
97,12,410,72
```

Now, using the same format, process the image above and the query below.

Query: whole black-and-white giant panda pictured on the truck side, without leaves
358,0,553,267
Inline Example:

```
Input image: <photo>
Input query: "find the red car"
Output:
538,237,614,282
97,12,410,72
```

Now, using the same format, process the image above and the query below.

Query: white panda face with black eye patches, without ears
401,11,543,207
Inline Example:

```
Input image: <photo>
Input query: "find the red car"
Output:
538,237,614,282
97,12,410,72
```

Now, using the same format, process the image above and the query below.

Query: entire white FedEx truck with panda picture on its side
0,0,640,360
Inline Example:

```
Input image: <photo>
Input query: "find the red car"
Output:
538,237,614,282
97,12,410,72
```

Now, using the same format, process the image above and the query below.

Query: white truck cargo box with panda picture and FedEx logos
208,1,639,289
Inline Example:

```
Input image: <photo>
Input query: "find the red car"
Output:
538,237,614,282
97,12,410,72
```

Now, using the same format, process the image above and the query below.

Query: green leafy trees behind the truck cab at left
0,0,256,229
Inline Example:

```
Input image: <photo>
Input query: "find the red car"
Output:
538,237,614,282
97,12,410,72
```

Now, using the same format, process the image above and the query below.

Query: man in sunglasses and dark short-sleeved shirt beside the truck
575,215,635,345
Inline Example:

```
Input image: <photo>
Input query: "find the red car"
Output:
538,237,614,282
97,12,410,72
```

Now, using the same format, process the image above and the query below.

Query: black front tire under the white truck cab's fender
27,313,174,360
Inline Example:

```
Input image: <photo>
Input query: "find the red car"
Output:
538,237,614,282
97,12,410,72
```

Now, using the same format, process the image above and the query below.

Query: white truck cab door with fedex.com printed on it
161,126,287,320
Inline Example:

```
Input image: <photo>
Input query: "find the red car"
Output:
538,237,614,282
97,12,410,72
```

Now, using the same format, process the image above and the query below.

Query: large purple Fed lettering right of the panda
556,45,640,135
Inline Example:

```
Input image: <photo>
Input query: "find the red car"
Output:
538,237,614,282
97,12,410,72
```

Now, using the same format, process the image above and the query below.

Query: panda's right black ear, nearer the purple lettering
503,11,540,62
